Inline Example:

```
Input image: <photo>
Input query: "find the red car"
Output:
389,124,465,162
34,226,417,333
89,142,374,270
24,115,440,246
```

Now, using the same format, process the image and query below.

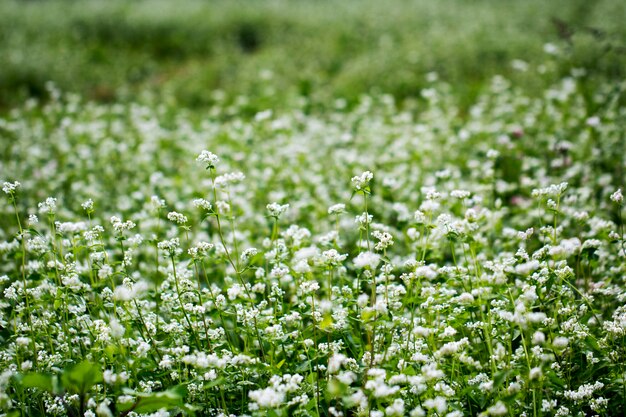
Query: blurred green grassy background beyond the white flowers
0,0,626,114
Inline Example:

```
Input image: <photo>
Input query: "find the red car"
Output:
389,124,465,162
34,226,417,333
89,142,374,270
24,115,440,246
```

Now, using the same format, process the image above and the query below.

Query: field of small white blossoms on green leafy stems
0,0,626,417
